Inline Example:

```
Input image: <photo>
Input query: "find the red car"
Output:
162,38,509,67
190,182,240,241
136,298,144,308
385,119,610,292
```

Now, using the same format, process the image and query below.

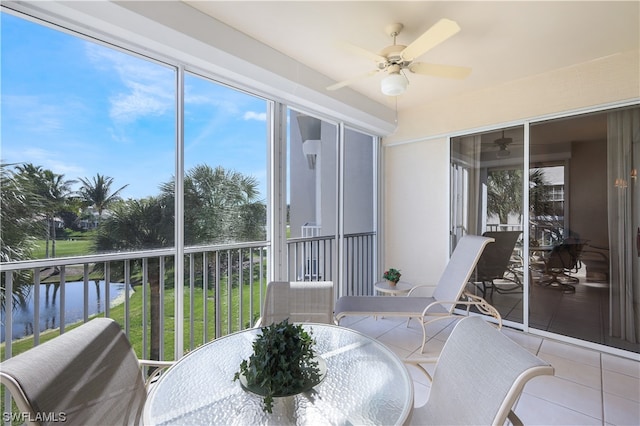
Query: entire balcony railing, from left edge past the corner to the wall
0,233,375,360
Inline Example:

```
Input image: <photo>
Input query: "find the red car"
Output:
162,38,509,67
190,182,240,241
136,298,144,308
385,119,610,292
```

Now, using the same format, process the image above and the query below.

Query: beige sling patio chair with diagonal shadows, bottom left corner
0,318,172,425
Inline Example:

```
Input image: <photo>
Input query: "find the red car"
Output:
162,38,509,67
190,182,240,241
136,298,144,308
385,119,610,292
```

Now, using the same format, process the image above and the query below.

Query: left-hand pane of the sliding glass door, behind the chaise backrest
450,126,526,324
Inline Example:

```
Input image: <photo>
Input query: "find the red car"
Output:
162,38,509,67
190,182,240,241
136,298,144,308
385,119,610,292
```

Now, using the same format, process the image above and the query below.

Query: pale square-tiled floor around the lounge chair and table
340,317,640,426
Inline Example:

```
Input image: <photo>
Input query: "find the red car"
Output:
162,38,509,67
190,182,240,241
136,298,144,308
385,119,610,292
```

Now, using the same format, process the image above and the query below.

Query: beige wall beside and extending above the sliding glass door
383,51,640,290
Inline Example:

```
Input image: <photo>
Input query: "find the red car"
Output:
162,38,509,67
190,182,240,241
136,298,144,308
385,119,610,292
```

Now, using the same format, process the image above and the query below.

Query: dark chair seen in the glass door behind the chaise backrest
474,231,522,297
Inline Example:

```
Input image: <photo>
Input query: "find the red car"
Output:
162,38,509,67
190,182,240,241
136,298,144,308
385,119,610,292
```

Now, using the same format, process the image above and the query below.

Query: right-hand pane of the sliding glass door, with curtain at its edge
529,108,640,352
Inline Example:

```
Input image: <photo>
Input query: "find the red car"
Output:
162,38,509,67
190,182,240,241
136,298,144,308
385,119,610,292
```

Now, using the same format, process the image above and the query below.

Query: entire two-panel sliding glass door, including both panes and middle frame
450,106,640,352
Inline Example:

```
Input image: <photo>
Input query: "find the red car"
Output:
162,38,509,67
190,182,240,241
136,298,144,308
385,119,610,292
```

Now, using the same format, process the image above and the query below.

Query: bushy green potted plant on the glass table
233,319,326,413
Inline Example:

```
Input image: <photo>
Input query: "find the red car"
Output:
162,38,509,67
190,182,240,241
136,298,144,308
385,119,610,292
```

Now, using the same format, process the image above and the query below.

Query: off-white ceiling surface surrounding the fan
183,0,640,110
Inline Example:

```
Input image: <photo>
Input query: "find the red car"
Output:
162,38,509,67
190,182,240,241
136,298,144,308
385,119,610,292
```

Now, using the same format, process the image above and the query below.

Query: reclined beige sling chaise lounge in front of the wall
334,235,502,352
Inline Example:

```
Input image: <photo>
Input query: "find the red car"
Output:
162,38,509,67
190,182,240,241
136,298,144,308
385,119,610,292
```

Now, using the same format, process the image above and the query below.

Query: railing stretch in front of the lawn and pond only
0,242,268,359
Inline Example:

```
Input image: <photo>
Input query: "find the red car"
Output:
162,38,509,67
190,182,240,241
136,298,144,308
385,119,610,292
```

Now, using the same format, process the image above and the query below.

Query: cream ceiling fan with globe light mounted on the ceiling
327,19,471,96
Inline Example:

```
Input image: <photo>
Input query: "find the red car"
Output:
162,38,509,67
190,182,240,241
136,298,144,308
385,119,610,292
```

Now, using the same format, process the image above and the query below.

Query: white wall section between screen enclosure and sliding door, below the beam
382,138,449,286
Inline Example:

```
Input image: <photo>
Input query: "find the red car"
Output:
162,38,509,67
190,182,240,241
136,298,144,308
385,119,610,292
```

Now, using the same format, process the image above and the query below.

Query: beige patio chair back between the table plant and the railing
255,281,334,327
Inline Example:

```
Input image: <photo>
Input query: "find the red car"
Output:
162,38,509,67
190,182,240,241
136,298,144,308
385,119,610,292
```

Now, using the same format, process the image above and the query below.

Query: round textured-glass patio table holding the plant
144,324,413,426
